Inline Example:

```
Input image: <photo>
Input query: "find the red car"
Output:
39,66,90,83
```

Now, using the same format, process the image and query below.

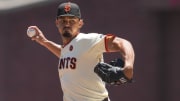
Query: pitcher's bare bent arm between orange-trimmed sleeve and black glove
108,37,135,79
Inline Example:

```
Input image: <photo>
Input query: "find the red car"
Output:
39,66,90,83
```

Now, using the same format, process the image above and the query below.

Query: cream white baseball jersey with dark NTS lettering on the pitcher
58,33,108,101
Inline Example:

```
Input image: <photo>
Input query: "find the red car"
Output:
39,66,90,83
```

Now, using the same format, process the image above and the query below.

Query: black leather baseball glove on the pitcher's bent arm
94,58,132,85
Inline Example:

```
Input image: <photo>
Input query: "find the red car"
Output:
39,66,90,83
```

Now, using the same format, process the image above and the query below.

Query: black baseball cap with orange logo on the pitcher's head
57,2,81,18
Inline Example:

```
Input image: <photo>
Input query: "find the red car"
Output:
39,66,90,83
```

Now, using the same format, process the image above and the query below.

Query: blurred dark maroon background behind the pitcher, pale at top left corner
0,0,180,101
